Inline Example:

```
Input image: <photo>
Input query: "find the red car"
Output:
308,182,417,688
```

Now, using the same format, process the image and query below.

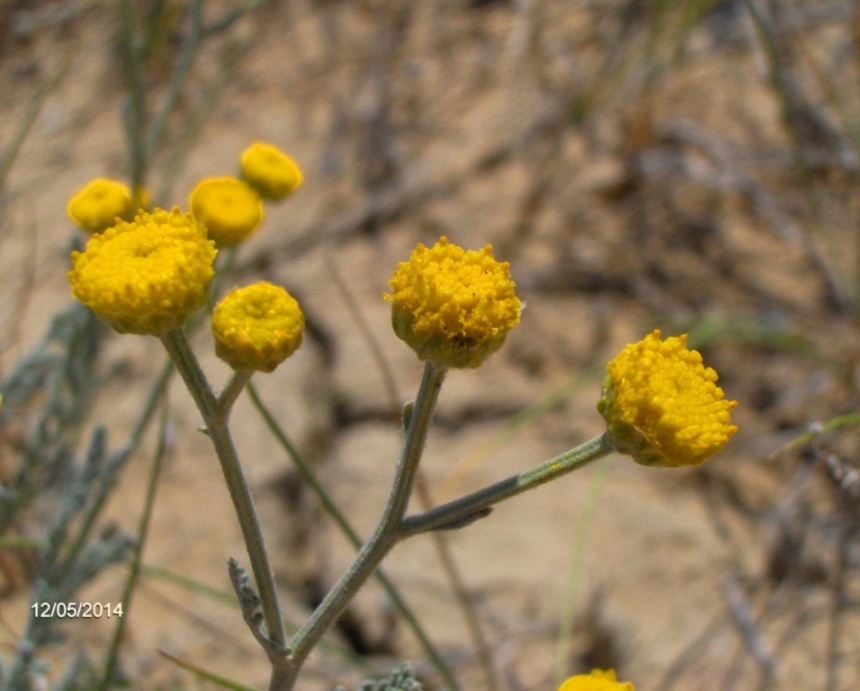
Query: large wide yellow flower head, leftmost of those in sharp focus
68,208,216,335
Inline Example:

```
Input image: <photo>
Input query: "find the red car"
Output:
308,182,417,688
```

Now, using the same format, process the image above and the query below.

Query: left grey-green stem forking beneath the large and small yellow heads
161,329,286,660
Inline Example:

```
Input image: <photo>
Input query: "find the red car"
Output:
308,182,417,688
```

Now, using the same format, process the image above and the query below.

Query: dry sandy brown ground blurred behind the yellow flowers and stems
0,0,860,691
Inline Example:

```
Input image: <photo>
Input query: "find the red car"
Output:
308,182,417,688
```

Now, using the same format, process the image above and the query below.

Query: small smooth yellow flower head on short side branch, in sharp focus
212,281,305,372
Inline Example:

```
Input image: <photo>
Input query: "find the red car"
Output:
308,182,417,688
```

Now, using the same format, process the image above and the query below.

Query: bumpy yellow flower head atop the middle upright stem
384,237,522,369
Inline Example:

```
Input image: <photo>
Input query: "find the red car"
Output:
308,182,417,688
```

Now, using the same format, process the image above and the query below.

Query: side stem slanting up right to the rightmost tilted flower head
396,433,613,540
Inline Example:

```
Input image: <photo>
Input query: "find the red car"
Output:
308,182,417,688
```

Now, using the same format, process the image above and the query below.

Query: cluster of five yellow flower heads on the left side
68,142,304,372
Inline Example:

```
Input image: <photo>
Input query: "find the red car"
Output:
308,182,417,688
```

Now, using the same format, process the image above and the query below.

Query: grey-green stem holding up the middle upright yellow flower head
283,363,445,691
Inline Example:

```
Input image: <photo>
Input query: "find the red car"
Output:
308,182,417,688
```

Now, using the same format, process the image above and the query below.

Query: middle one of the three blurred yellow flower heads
188,177,263,247
